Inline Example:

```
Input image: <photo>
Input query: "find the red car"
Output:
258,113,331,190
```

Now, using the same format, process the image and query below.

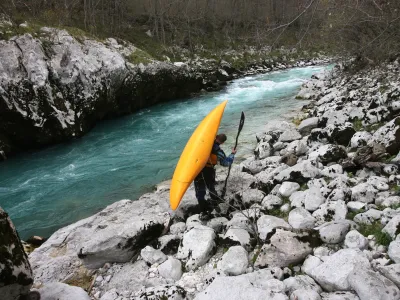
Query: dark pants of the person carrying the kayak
194,167,218,211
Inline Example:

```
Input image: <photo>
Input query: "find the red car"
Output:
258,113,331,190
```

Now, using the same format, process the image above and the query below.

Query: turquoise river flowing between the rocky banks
0,66,326,239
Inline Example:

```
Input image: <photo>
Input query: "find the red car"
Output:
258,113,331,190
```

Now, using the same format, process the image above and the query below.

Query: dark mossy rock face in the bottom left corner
0,207,33,300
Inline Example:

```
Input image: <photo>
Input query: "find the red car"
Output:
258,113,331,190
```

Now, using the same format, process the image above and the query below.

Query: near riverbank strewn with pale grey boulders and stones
3,57,400,300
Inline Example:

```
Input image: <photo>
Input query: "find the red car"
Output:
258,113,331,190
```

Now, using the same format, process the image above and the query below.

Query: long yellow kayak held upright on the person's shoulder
169,100,228,210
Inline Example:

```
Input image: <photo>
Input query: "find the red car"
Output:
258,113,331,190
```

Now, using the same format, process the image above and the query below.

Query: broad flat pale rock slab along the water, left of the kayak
29,196,170,283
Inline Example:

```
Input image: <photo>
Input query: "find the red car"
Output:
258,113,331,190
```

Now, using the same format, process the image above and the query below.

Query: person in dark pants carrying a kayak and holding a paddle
194,133,236,213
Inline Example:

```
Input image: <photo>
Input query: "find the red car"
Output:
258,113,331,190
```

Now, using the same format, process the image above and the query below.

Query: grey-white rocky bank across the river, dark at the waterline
0,22,329,160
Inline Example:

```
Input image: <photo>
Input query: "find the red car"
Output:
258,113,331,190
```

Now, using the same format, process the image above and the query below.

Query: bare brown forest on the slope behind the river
0,0,400,61
